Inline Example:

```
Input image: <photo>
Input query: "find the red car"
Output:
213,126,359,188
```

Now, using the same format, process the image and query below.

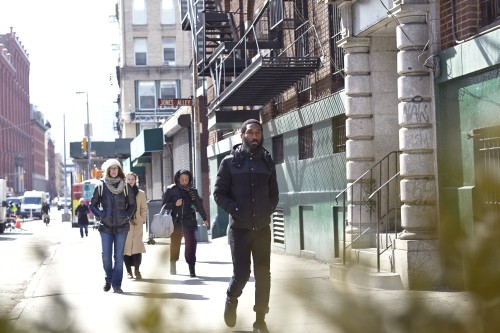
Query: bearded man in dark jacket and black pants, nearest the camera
213,119,279,332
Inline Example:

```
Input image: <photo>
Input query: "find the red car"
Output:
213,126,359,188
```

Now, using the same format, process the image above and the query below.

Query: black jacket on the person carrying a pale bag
162,184,207,229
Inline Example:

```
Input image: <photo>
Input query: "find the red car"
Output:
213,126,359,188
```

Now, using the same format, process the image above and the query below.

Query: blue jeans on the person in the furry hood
100,232,128,288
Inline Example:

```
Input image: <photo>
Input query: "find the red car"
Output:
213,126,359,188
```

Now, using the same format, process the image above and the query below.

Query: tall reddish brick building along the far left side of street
0,29,48,195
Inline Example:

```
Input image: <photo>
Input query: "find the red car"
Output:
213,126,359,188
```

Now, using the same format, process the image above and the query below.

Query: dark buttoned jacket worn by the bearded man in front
213,144,279,230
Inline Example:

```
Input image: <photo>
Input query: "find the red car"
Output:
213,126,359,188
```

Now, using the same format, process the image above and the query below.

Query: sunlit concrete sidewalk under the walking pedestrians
10,218,471,333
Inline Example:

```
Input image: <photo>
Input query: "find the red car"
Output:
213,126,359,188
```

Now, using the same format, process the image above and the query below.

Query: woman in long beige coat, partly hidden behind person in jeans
123,172,148,279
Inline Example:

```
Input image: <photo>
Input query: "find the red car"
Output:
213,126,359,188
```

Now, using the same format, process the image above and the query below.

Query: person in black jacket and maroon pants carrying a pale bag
163,169,208,277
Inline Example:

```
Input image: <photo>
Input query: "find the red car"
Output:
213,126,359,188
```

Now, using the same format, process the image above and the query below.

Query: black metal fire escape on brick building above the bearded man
179,0,320,130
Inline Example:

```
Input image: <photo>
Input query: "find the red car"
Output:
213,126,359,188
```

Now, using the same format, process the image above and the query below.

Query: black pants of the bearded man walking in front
227,226,271,313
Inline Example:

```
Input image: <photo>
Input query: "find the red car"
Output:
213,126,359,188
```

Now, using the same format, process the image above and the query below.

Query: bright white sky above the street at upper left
0,0,119,160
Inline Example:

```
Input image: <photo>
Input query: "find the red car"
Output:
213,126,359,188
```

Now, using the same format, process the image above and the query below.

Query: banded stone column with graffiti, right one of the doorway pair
391,0,440,289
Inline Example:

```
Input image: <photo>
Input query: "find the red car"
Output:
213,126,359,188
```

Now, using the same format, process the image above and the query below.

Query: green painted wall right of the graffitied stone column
436,30,500,286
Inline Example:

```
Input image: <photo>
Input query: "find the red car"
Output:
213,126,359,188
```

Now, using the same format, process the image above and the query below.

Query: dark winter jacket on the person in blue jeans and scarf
89,182,136,234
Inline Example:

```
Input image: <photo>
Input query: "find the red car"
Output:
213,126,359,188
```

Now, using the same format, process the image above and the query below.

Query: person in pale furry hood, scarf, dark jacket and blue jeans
90,159,135,294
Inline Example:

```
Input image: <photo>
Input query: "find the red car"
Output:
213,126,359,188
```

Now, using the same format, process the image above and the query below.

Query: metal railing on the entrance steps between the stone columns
335,151,401,272
